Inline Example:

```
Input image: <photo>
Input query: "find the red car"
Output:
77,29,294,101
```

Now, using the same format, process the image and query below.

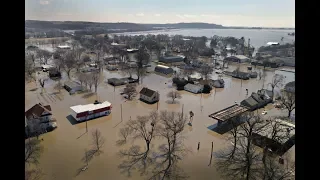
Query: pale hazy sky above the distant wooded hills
25,0,295,28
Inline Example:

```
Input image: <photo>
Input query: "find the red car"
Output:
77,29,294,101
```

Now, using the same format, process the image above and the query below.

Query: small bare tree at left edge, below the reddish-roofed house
24,138,43,165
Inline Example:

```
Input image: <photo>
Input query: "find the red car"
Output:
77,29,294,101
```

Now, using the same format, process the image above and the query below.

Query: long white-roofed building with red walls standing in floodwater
70,101,112,121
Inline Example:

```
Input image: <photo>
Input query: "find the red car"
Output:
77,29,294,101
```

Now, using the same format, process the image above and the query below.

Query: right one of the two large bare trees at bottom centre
150,111,187,180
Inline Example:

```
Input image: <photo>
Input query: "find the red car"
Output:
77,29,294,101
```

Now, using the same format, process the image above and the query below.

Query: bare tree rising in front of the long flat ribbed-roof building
216,113,264,180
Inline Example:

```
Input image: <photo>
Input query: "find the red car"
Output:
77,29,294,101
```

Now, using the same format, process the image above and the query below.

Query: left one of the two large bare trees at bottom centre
119,112,158,175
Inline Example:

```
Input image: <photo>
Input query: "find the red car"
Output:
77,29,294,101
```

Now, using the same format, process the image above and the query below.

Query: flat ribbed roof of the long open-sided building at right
209,104,249,121
